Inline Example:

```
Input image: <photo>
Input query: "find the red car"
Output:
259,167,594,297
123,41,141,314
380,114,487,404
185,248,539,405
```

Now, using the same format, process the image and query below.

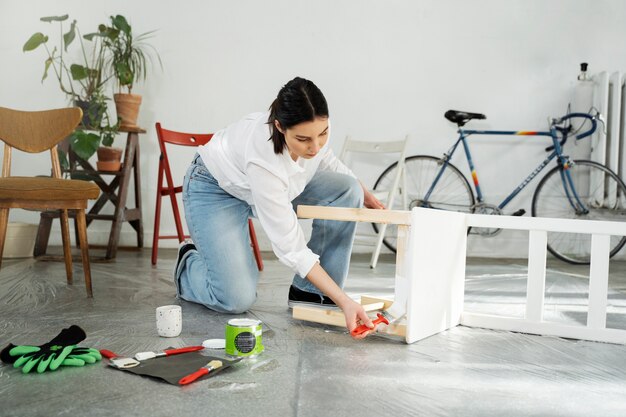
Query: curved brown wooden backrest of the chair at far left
0,107,83,178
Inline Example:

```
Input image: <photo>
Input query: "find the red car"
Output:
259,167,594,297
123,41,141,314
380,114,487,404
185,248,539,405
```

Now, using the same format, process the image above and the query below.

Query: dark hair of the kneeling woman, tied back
267,77,328,154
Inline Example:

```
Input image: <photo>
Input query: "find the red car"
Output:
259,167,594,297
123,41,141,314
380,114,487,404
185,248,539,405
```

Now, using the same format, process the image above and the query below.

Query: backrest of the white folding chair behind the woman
339,135,409,208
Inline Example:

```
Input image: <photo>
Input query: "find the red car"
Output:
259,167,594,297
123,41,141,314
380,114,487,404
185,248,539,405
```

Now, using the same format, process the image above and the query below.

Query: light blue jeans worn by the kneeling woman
174,155,363,313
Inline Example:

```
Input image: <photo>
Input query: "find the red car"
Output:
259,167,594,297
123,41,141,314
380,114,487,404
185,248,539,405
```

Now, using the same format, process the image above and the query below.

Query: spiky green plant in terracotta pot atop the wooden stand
99,15,161,129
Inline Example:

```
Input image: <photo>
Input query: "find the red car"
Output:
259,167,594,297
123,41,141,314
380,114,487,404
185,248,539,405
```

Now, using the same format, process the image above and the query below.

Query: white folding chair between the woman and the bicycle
339,135,409,268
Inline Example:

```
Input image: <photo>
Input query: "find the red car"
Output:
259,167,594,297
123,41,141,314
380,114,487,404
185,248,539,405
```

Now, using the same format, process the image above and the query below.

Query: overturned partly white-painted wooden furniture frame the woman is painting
293,206,626,344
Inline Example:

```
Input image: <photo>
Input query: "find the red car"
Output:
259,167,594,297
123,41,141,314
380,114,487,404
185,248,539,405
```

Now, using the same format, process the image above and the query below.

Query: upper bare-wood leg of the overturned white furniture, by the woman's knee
298,205,411,225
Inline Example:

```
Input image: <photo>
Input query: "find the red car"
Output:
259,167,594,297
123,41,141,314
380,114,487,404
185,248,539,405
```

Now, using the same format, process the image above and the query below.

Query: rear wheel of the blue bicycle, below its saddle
372,155,474,252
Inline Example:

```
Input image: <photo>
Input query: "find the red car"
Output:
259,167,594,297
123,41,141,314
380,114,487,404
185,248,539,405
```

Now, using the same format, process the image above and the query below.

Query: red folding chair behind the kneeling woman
152,123,263,271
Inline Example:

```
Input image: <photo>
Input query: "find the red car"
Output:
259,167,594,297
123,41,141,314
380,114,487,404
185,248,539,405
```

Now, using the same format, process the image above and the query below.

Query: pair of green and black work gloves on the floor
0,325,87,374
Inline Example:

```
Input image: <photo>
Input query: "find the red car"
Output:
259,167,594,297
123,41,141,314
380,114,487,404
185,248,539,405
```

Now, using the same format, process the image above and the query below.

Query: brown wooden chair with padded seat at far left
0,107,100,297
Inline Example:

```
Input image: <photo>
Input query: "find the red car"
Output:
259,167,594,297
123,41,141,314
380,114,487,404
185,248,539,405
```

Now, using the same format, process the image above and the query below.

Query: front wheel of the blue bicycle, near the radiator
532,160,626,265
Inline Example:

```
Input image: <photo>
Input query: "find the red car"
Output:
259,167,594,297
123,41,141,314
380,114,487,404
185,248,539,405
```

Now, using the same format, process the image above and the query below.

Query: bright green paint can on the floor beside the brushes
226,319,264,358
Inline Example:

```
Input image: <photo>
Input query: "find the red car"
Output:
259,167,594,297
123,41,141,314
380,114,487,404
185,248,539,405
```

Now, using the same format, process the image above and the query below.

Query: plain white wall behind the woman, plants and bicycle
0,0,626,255
